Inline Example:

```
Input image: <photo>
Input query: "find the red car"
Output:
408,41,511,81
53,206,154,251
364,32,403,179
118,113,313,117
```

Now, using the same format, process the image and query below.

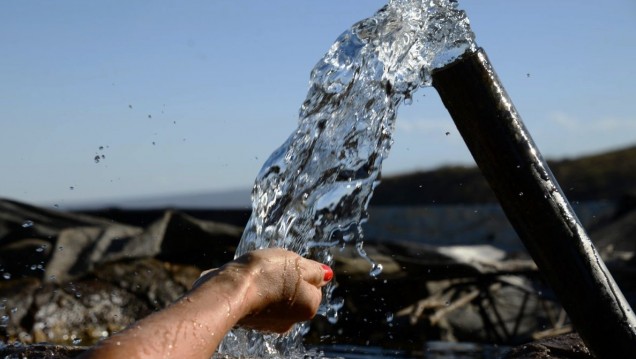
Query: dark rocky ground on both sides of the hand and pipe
0,194,636,358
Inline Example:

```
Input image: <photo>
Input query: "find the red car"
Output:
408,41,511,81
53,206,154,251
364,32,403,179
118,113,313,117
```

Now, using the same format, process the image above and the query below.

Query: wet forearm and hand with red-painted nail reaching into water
76,248,333,359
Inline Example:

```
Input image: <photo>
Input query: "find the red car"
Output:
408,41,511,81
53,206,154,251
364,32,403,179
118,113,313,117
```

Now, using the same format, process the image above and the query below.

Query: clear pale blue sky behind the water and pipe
0,0,636,207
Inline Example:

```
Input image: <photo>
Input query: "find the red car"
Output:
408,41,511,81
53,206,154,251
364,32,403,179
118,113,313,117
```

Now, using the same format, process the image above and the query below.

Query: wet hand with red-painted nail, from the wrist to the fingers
194,248,333,333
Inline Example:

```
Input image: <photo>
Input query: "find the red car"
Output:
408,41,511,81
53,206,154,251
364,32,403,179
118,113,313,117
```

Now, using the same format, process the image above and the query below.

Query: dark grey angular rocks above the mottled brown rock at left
0,199,243,283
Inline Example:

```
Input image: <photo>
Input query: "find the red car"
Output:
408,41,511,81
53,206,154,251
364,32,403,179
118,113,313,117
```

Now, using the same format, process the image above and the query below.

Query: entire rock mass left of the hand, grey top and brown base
0,199,242,345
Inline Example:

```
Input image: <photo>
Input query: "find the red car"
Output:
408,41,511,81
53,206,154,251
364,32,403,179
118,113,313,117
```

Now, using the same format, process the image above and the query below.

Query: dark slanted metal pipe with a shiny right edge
433,49,636,358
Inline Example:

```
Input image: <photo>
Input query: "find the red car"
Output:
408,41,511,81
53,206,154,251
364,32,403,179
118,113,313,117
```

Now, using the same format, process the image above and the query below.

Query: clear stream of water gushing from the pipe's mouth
216,0,475,358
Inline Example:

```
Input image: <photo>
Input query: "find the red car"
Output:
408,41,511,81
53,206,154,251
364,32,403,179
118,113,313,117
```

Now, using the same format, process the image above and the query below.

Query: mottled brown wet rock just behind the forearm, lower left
0,258,201,345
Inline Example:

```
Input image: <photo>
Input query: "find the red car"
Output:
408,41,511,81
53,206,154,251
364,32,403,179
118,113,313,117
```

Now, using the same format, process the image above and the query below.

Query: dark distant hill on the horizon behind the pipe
371,146,636,206
